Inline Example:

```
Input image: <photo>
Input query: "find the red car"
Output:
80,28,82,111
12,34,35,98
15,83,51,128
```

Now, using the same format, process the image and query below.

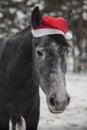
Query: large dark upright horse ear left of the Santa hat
31,7,42,29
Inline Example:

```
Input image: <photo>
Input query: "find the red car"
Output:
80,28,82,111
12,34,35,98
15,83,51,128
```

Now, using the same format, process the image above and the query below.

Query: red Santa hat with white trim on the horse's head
31,16,72,40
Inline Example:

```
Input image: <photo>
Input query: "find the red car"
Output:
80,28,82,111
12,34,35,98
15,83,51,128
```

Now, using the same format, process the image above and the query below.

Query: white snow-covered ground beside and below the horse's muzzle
38,73,87,130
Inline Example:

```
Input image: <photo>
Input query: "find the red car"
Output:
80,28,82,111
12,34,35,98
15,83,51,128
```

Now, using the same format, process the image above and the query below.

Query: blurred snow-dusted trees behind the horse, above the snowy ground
0,0,87,72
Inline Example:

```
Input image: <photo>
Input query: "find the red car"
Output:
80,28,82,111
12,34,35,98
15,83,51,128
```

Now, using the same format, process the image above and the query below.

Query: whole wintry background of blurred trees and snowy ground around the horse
0,0,87,130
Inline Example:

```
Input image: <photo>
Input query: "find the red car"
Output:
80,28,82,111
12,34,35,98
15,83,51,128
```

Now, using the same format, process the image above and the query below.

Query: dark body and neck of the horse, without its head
0,28,39,130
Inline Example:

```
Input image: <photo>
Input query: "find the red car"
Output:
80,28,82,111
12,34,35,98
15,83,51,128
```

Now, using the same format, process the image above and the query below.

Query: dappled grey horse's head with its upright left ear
32,8,70,113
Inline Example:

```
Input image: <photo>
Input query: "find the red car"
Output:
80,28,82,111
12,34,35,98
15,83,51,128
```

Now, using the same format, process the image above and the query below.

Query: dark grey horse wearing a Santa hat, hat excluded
0,7,70,130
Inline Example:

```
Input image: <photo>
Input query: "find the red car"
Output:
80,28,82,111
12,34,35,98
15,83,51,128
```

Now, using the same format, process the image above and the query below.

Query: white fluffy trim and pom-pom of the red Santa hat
31,29,72,40
